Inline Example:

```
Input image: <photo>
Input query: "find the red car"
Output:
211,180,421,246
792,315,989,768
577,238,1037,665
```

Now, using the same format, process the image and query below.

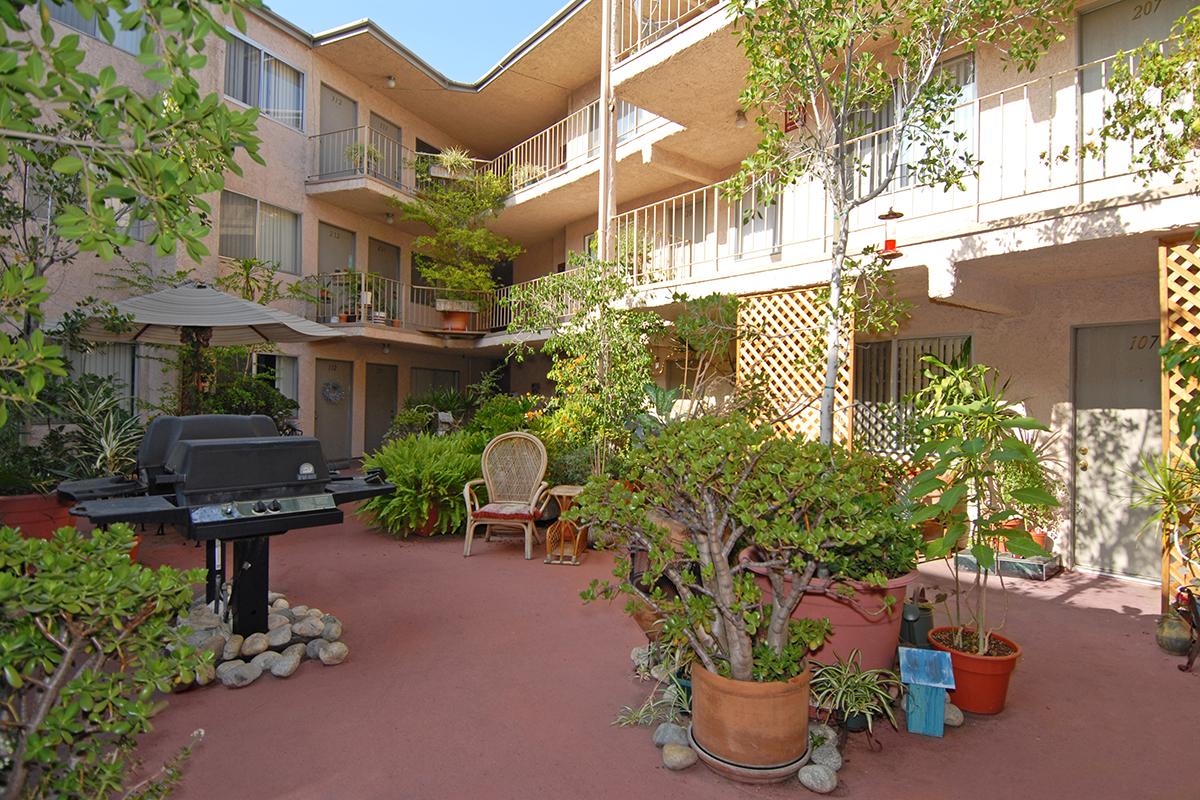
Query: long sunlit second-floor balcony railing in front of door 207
613,47,1169,284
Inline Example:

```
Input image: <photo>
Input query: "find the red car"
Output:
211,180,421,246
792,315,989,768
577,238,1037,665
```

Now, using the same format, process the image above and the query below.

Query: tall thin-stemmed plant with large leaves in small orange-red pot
911,356,1057,714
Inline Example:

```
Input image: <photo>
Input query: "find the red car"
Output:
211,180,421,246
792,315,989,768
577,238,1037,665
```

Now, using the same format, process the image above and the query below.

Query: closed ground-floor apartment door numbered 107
1074,323,1163,581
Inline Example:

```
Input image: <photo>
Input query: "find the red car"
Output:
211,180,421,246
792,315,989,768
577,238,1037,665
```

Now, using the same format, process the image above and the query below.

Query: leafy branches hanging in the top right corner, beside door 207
1102,8,1200,184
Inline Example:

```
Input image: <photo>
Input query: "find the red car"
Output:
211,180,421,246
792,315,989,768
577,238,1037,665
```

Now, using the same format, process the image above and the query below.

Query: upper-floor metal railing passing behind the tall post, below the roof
480,101,667,192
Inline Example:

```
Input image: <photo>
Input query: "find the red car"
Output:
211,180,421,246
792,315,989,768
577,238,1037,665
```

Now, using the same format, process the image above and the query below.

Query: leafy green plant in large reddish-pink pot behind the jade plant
738,453,922,669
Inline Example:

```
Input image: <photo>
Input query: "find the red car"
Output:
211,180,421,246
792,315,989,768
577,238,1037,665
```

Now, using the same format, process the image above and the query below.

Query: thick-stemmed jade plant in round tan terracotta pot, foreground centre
568,414,895,782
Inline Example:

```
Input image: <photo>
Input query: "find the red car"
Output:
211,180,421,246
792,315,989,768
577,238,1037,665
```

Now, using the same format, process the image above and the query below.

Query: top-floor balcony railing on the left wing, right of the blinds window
308,125,451,193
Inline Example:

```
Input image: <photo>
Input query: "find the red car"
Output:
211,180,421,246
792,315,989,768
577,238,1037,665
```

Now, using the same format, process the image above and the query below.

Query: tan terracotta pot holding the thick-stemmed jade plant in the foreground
691,664,811,783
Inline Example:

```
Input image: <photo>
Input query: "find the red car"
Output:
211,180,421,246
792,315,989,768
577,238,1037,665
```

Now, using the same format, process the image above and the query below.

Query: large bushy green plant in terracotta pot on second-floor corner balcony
395,150,521,331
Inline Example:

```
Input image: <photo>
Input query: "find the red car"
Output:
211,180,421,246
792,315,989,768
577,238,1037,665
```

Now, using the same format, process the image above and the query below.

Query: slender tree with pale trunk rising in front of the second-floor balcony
726,0,1072,443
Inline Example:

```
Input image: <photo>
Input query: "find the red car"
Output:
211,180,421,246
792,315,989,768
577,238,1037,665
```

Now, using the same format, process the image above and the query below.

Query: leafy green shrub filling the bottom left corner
0,525,211,798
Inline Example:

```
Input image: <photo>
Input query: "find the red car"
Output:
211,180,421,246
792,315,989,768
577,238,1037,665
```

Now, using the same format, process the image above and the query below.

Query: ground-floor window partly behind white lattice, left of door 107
854,336,971,455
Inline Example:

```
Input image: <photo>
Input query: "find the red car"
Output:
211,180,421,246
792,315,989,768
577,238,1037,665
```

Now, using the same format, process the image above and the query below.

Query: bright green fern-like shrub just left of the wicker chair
361,433,480,536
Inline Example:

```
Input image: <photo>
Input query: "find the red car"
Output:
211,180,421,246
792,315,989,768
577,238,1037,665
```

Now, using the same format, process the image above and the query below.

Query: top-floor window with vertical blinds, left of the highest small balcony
226,36,305,131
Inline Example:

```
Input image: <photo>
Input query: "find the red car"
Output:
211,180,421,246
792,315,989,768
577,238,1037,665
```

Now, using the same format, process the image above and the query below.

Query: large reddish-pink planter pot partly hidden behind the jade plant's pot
738,548,917,669
